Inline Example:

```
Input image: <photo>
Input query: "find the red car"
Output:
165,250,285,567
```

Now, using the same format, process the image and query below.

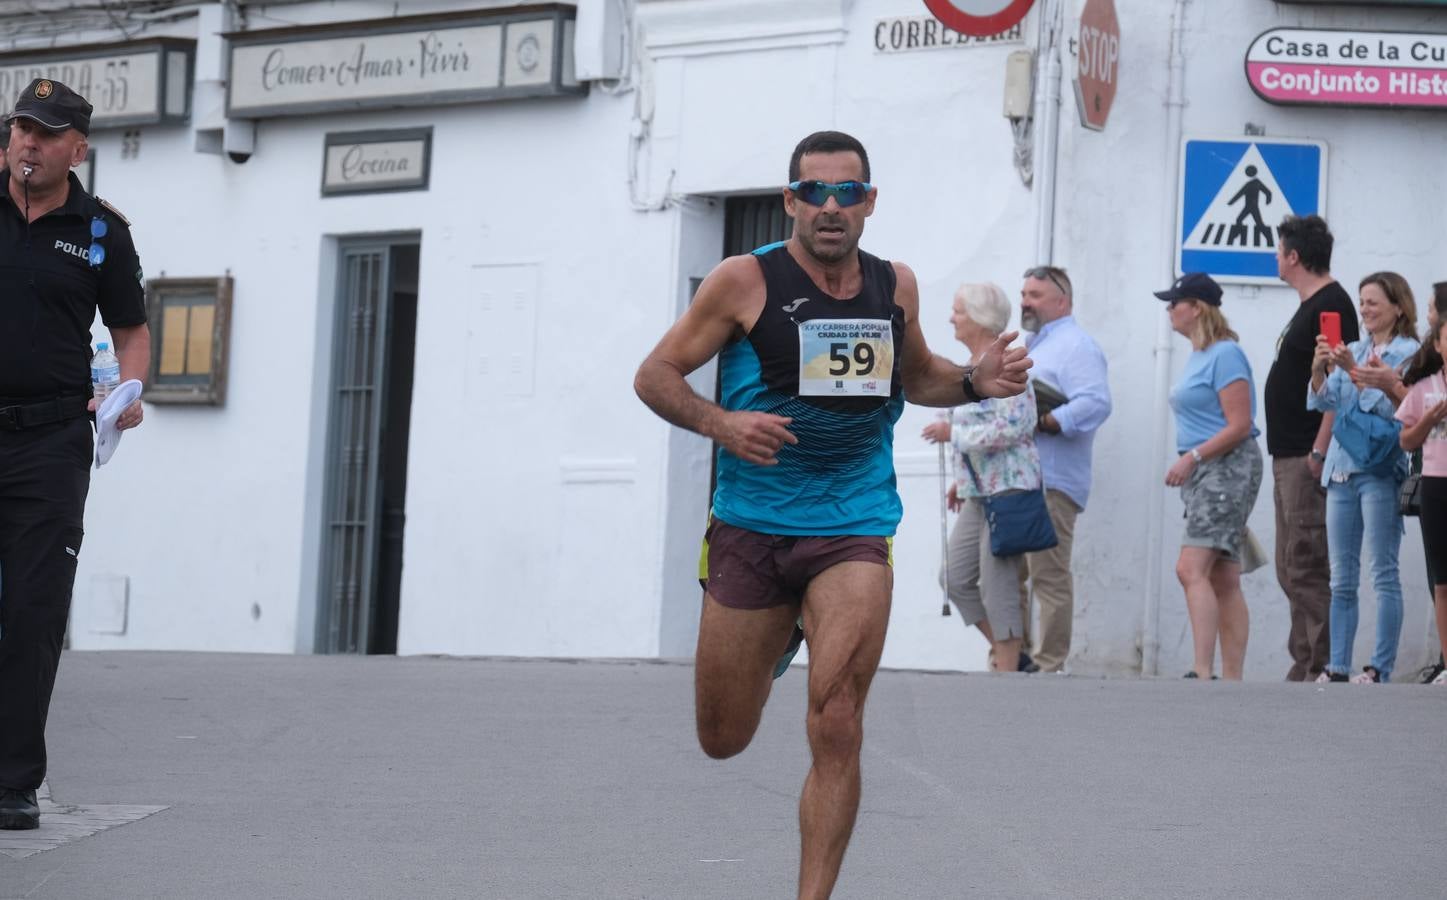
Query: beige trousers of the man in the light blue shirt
1020,489,1081,671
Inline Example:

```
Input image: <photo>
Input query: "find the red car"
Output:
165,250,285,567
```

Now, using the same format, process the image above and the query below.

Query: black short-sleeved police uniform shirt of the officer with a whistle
0,169,146,399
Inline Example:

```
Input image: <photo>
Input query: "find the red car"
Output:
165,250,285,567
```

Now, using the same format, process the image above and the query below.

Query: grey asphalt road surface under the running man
0,653,1447,900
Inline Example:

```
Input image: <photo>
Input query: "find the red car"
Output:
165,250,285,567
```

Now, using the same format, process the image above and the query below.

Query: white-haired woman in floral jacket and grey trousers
923,284,1040,671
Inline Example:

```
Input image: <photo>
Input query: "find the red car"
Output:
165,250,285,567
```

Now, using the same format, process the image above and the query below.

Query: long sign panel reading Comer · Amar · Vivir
226,3,587,119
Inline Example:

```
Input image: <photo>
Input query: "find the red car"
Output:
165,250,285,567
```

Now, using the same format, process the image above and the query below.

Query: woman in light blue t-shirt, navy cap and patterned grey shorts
1156,272,1262,682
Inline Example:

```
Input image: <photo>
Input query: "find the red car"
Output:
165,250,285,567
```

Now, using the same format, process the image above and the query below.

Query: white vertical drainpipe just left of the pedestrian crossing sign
1140,0,1191,676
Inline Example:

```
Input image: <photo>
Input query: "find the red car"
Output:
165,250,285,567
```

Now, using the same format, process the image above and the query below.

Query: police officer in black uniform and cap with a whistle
0,78,150,829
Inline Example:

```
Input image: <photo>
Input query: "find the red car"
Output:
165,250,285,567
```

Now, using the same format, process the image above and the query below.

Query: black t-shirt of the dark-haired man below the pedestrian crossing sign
1266,281,1360,457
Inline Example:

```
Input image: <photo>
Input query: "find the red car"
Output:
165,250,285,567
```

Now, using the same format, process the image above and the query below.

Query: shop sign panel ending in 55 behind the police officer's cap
0,38,195,129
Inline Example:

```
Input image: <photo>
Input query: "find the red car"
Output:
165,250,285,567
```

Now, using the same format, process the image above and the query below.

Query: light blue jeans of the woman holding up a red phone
1327,473,1402,682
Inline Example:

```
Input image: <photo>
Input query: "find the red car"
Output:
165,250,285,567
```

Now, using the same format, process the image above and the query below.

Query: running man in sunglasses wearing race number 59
634,132,1030,899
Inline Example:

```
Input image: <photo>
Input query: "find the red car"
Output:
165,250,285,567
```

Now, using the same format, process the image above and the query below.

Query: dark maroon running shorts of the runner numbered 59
699,519,894,609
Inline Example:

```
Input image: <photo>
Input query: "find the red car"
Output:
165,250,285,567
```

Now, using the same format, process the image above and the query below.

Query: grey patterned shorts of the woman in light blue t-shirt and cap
1181,437,1262,563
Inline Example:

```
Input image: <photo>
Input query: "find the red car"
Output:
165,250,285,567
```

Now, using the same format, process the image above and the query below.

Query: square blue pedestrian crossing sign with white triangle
1176,137,1327,285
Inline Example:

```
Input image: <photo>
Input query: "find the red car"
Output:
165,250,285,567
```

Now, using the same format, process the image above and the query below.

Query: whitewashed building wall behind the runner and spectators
36,0,1444,679
